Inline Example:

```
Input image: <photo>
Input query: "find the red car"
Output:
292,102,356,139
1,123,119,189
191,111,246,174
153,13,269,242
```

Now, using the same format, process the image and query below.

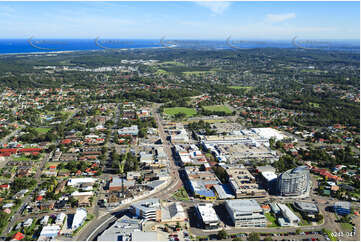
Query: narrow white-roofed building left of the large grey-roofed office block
195,203,219,229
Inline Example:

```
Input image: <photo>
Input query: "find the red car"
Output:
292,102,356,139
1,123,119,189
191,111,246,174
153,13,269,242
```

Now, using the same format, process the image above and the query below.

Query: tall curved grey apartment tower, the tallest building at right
277,166,310,196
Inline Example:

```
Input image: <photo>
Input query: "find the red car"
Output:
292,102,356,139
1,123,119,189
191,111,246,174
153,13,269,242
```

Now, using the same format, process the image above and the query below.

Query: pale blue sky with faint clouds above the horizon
0,2,360,39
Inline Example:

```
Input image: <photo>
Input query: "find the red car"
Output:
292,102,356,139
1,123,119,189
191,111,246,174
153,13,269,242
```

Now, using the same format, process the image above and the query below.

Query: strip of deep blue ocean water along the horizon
0,39,360,54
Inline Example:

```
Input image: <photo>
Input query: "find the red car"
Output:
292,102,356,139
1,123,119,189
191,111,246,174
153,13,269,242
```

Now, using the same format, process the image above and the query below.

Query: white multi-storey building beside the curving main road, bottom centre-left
131,198,162,222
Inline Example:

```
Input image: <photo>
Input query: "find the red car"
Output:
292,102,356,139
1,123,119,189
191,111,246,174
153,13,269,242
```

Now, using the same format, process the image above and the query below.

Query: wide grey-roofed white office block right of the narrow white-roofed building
225,199,266,227
